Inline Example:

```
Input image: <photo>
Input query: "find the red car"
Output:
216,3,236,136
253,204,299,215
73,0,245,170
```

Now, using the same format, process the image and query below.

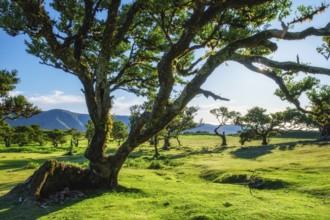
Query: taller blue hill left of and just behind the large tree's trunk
7,109,129,131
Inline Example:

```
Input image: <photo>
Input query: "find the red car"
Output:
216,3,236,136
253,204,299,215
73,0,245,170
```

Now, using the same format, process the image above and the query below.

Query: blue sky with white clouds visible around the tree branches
0,0,330,124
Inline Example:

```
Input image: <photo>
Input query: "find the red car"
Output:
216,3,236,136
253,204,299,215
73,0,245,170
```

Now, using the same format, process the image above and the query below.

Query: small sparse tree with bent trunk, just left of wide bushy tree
210,107,239,146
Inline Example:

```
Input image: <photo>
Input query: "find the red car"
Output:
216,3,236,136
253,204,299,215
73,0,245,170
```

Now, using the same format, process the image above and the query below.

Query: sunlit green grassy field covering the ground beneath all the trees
0,136,330,220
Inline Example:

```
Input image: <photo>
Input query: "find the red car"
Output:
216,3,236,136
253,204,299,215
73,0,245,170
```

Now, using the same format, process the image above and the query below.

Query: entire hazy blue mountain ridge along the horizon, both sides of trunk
7,109,240,134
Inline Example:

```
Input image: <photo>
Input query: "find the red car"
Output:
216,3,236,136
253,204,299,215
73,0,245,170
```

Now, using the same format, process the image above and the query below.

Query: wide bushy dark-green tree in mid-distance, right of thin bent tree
235,107,307,145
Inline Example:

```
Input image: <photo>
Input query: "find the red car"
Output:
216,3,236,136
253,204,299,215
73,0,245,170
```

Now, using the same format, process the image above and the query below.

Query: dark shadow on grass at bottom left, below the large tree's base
0,186,145,220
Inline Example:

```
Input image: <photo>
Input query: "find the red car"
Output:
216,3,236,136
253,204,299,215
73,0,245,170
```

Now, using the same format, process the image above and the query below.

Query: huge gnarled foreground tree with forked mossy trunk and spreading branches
0,0,330,198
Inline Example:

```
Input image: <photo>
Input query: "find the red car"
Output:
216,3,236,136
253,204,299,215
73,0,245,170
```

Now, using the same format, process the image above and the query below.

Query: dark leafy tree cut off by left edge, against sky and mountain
0,70,40,121
